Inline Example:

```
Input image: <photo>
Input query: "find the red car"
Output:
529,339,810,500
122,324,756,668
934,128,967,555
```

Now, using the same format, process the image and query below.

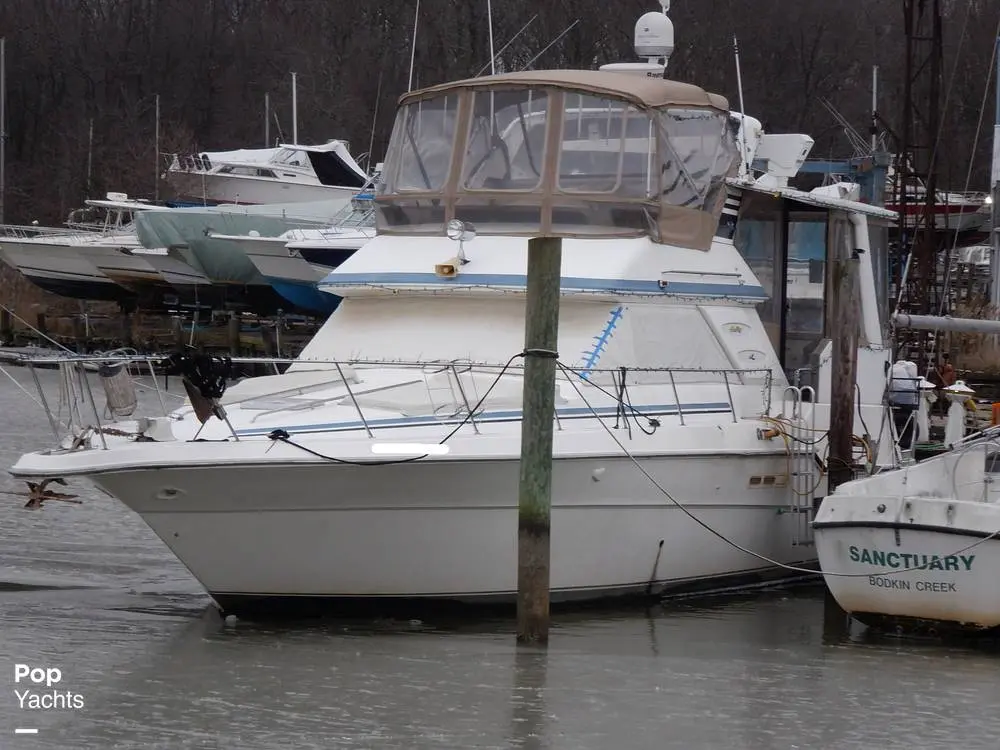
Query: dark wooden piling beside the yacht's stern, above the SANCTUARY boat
829,236,861,492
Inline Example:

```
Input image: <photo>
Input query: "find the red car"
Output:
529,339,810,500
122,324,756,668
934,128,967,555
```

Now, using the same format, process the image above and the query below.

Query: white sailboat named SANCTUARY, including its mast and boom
813,40,1000,636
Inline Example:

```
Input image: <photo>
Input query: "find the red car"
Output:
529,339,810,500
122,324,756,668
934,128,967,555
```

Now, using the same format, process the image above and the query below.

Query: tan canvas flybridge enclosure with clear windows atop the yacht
376,70,738,250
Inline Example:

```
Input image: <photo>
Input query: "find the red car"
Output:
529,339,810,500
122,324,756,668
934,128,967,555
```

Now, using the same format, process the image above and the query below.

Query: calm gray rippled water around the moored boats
0,369,1000,750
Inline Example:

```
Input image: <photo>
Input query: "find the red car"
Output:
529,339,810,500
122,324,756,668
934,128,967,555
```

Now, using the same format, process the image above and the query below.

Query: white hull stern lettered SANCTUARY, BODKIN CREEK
814,495,1000,634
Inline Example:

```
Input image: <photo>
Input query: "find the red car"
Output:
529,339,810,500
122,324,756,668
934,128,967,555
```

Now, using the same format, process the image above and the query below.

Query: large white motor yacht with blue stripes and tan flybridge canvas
5,2,895,617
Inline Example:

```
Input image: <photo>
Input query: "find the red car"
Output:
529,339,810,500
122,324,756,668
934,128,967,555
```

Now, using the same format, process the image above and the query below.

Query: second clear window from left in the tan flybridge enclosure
462,89,549,190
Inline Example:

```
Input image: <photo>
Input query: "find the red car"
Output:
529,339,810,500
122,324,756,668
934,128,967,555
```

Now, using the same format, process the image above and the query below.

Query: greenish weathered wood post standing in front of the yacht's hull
517,237,562,643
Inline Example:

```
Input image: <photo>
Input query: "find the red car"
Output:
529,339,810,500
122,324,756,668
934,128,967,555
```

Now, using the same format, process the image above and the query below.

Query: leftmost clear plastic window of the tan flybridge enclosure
392,96,458,192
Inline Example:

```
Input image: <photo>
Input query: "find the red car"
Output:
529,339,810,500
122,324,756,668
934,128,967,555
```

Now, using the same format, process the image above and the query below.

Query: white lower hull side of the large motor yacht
86,455,813,614
